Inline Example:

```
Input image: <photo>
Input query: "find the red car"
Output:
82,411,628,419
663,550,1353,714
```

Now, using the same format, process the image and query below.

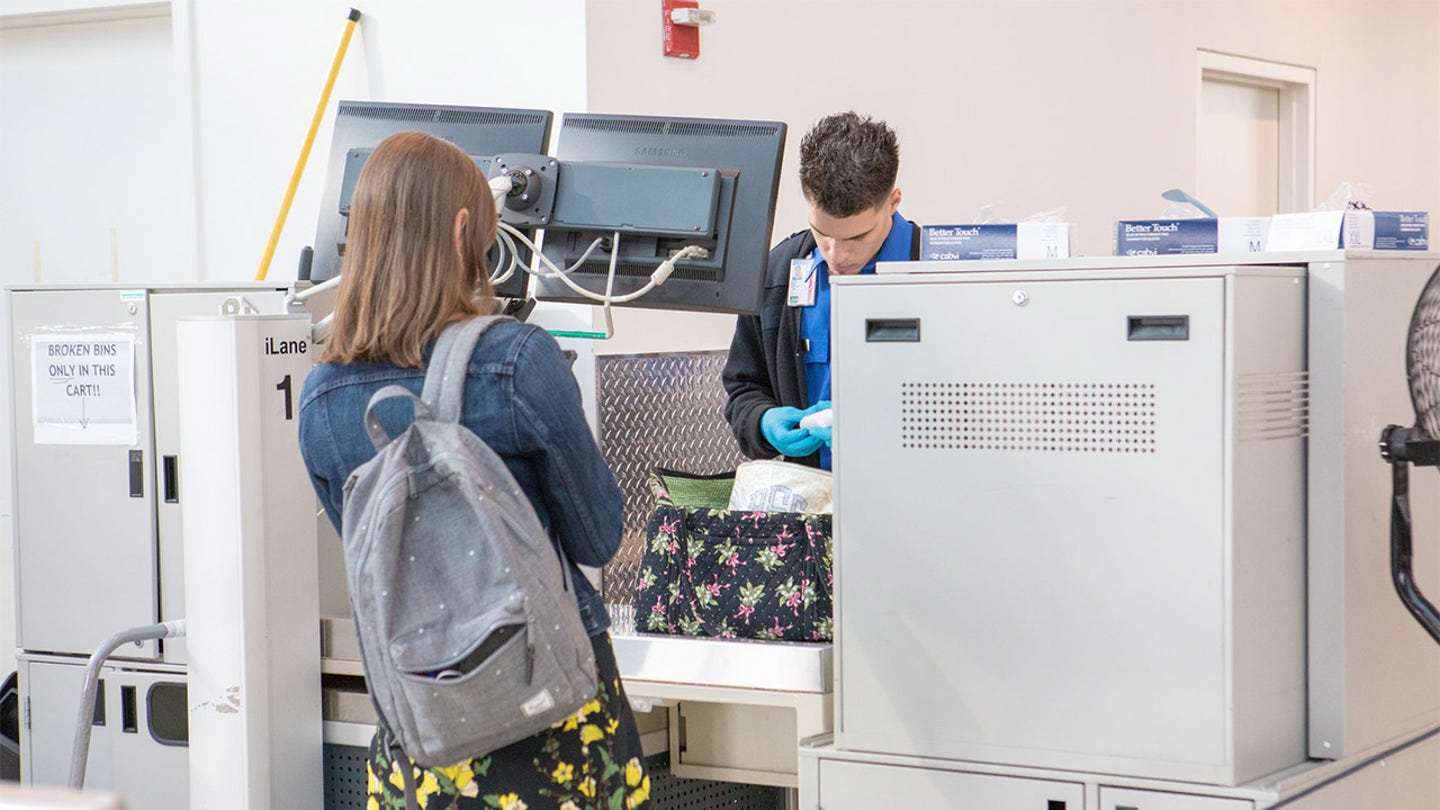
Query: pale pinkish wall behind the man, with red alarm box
586,0,1440,266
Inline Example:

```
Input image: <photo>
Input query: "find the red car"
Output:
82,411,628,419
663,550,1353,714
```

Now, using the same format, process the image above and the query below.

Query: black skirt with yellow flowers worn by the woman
366,633,649,810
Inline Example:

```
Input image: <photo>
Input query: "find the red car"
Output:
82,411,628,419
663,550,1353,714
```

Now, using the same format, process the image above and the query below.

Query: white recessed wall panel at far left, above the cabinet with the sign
0,14,186,284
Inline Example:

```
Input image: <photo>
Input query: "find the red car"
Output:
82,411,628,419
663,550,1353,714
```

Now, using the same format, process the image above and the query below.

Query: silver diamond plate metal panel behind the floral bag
595,352,744,611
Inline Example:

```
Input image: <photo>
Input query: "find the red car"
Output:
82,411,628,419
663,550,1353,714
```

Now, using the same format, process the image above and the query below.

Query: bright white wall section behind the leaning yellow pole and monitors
177,0,586,280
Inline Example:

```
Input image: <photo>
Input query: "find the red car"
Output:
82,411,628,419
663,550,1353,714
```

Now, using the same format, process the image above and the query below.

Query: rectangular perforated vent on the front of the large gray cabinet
900,380,1156,453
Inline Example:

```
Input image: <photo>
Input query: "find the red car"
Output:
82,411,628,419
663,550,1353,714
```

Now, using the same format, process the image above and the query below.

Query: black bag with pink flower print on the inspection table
635,470,834,641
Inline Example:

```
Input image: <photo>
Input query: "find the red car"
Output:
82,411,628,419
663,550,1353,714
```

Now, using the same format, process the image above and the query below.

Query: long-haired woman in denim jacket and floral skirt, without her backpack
300,133,649,810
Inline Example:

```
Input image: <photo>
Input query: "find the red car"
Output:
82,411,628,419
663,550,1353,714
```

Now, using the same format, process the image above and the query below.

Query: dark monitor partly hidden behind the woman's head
310,101,553,298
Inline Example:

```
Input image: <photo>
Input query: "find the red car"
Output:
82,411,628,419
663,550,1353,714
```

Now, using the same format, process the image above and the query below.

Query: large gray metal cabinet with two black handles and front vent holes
834,267,1305,784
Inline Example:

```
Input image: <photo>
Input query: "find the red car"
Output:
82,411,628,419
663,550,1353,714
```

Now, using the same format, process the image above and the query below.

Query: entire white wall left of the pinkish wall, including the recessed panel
0,0,586,281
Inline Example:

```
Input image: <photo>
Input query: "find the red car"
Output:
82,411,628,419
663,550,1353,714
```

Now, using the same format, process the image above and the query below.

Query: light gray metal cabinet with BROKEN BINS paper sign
9,284,285,663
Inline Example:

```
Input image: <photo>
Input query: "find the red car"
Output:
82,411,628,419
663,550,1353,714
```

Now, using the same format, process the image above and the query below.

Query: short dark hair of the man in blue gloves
801,112,900,216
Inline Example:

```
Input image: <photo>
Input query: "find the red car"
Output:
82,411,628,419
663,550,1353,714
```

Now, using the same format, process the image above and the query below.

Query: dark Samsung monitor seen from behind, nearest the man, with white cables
534,112,785,313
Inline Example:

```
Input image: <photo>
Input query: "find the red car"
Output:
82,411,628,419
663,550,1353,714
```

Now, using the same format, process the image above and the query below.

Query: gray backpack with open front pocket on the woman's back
341,317,596,774
